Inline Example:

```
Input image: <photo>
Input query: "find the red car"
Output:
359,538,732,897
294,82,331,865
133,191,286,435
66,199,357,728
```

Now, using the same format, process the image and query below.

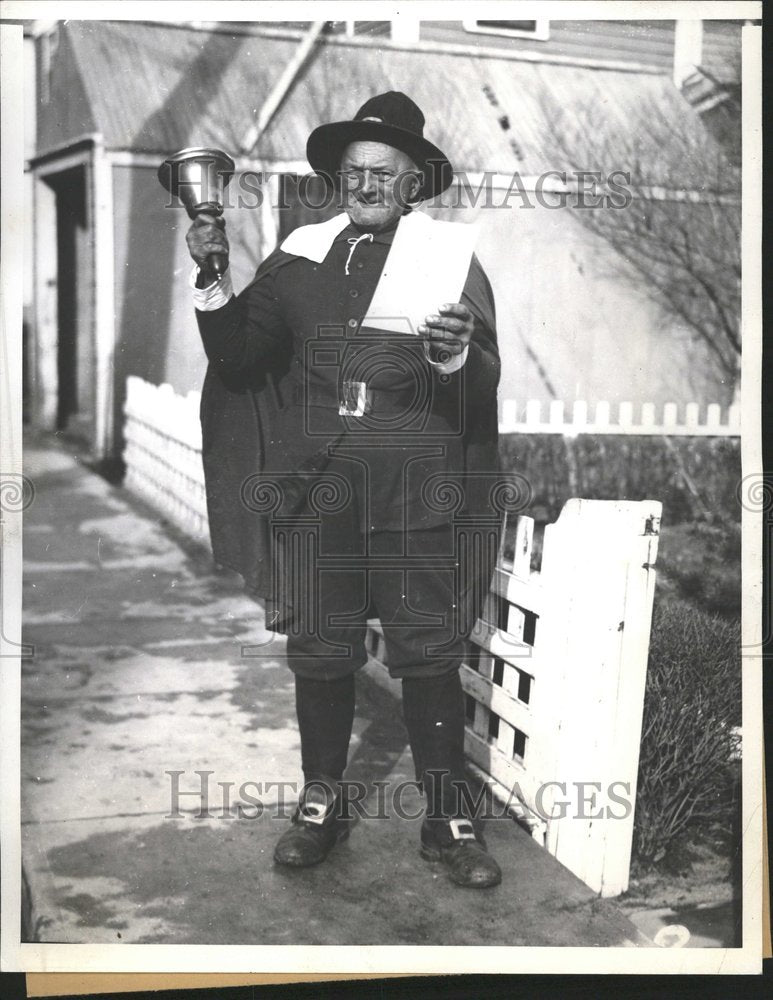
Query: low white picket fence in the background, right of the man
499,399,741,437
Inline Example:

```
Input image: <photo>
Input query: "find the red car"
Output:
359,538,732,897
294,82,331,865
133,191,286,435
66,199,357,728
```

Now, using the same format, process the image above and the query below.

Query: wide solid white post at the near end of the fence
528,500,661,896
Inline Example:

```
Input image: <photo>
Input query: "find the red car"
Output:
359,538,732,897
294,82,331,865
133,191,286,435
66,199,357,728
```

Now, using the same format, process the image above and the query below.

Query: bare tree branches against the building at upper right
541,88,741,398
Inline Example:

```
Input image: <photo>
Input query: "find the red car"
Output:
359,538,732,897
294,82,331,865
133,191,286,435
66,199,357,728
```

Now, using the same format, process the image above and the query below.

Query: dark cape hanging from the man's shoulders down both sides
196,230,501,631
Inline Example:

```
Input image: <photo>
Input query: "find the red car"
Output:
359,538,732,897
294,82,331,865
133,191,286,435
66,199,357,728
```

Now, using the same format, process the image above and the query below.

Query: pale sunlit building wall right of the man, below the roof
432,191,730,405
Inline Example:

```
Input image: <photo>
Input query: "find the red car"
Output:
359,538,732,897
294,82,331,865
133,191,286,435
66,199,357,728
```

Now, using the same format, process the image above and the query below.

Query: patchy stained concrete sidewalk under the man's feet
21,441,646,946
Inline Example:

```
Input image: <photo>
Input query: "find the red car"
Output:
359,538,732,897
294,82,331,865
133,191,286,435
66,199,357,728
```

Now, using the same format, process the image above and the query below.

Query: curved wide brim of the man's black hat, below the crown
306,121,454,199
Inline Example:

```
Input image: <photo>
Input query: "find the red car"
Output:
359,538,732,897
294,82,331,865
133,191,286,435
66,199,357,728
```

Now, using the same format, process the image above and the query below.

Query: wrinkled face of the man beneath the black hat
341,142,421,233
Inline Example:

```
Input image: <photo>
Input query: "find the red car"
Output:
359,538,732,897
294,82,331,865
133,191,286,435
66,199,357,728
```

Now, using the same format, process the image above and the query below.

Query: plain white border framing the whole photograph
0,0,766,973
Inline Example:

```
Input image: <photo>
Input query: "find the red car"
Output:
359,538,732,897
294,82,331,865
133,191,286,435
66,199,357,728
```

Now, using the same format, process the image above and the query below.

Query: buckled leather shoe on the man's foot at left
274,782,350,868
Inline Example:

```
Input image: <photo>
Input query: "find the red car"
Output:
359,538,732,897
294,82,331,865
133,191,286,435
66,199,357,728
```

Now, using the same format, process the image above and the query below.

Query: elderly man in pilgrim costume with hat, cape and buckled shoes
188,92,501,887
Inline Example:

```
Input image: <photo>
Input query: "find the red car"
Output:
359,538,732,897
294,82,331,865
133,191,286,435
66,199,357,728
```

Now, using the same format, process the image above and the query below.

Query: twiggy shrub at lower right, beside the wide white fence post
634,599,741,862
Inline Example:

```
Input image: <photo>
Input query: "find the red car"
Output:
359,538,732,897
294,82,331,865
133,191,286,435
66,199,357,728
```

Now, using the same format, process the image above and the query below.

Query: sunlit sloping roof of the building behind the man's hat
38,21,724,184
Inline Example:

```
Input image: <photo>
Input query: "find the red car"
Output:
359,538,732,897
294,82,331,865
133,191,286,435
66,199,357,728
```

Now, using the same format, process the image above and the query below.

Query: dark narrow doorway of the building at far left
46,166,96,445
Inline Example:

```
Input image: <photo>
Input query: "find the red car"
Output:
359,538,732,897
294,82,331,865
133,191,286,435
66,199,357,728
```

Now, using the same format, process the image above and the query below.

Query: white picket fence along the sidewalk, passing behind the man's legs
124,378,661,896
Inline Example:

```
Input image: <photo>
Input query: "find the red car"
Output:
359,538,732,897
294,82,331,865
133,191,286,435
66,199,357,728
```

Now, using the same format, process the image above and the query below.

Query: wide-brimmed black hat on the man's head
306,90,454,199
